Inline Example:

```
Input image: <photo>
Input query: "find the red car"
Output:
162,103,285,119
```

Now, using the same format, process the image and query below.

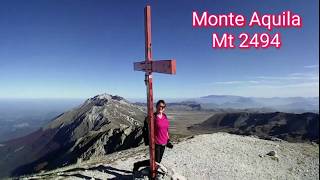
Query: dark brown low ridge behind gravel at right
189,112,319,143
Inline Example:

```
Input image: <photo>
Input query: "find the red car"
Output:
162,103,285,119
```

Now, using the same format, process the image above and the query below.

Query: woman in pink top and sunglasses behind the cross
133,100,173,172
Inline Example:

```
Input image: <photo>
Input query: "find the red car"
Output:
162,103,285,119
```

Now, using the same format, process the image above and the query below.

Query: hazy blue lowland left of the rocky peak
0,99,83,142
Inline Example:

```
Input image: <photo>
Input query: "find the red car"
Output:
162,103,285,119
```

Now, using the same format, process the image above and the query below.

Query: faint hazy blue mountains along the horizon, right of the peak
133,95,319,113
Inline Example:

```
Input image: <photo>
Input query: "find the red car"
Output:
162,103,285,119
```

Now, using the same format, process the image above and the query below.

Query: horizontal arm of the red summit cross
133,60,176,74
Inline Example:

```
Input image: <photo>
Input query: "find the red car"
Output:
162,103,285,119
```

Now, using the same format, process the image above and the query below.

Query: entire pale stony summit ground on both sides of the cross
20,133,319,180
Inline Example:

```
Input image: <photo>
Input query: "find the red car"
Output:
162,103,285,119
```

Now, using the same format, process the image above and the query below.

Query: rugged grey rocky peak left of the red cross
0,94,145,177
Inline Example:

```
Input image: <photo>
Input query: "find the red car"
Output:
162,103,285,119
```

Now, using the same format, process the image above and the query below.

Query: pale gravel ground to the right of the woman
163,133,319,179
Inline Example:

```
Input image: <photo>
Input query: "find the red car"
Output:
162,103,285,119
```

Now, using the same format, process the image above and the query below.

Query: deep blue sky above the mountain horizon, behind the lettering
0,0,319,98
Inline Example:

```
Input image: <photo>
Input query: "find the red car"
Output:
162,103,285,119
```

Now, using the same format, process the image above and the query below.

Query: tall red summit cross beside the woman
134,5,176,179
